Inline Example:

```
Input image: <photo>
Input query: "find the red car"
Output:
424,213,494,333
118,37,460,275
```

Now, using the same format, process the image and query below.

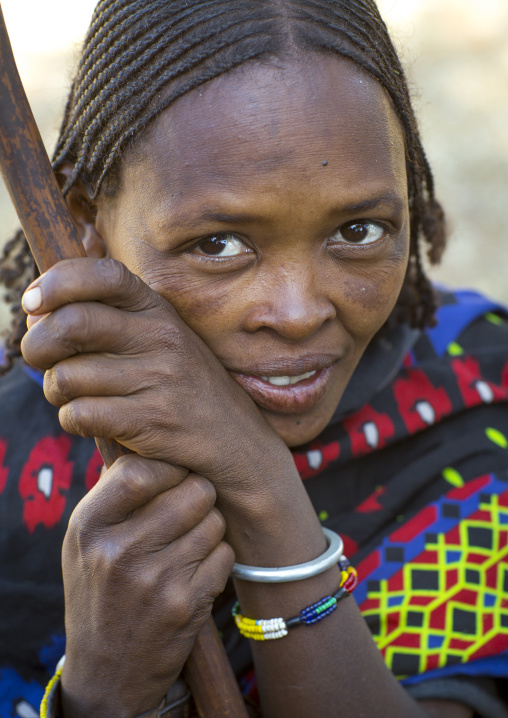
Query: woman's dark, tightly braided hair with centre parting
0,0,445,372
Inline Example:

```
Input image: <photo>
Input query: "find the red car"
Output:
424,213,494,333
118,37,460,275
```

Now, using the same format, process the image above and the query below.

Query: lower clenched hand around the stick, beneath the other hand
62,455,234,718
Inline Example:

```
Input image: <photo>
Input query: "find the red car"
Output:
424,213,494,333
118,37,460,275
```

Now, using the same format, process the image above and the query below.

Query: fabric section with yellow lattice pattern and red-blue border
356,475,508,678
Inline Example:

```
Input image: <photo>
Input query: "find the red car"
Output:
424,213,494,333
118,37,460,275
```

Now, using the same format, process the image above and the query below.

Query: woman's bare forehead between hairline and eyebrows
118,54,406,212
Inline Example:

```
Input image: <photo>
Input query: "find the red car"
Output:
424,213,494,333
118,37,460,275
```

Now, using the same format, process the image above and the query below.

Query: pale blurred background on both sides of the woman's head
0,0,508,336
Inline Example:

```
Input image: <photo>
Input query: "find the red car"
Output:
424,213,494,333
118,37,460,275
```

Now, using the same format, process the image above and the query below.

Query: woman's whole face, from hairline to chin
96,55,409,446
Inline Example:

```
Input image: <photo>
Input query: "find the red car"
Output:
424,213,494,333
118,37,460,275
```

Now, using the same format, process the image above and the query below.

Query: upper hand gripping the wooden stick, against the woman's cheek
22,258,294,496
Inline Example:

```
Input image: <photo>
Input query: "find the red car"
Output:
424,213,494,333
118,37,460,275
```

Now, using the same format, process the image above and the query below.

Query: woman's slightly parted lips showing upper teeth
230,362,336,414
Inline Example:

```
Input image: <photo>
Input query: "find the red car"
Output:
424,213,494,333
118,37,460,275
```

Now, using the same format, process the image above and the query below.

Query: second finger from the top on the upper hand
21,302,150,370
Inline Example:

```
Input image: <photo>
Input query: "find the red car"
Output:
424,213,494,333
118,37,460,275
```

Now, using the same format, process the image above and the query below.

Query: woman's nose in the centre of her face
244,266,337,341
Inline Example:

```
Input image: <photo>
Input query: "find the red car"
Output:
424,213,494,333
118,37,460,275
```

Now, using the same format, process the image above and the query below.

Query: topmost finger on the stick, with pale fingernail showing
22,257,169,315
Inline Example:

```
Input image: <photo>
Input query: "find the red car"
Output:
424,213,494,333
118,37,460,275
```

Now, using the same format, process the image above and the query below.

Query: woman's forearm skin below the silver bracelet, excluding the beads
238,584,427,718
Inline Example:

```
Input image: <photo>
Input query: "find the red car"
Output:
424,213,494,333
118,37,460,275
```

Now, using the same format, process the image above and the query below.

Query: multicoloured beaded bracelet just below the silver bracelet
232,556,358,641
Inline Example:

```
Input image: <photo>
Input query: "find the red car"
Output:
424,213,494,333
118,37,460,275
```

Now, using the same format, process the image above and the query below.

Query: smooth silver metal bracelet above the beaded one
231,527,344,583
